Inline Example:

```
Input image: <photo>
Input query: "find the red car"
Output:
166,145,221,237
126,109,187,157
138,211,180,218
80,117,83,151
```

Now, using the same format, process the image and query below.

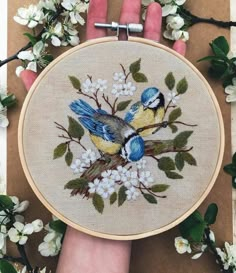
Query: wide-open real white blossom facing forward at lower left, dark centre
8,222,34,245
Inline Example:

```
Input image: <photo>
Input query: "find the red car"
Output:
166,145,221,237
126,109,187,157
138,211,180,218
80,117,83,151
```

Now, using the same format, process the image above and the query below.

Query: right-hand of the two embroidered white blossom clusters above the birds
111,72,137,98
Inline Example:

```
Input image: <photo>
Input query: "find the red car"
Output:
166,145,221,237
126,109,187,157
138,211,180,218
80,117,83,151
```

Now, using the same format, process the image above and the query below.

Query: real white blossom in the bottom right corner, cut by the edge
216,242,236,273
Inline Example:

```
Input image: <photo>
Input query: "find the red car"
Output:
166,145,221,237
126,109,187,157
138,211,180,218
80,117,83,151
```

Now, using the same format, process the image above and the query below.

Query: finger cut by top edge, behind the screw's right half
120,0,141,40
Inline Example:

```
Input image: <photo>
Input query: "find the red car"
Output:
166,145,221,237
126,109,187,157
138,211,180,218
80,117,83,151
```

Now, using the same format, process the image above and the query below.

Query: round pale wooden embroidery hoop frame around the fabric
18,37,225,240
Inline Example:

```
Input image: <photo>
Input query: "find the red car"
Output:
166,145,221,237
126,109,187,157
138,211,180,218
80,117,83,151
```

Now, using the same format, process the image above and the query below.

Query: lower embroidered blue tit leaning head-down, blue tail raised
70,99,144,161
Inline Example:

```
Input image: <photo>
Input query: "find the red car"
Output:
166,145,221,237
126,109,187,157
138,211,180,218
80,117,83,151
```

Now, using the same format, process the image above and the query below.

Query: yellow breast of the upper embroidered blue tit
130,106,165,137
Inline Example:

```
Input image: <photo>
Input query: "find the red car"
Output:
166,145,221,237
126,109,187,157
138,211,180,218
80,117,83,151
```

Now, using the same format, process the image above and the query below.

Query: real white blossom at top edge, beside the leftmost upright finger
61,0,88,25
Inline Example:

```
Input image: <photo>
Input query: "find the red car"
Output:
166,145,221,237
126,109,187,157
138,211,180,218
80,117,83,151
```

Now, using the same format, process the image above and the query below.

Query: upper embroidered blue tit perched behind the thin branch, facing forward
124,87,165,137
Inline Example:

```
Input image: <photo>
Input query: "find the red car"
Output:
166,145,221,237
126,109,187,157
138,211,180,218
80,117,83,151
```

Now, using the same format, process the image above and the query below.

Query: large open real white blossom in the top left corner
13,5,44,28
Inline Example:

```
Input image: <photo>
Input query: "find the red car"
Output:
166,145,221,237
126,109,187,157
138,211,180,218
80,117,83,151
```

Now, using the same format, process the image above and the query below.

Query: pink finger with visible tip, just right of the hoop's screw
144,3,162,42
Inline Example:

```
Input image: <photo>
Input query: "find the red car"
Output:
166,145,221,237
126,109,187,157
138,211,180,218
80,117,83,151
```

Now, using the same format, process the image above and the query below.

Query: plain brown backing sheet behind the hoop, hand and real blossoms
8,0,232,273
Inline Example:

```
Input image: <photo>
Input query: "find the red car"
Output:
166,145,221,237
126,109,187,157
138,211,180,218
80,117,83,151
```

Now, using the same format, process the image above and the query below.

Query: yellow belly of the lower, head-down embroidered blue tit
90,134,121,155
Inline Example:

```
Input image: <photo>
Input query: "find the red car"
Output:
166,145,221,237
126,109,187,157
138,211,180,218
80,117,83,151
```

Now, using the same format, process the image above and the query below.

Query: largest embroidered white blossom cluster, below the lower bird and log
89,159,154,201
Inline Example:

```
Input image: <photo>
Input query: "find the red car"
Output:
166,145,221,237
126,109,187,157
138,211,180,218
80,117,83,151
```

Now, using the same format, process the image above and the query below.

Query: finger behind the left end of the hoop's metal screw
86,0,107,40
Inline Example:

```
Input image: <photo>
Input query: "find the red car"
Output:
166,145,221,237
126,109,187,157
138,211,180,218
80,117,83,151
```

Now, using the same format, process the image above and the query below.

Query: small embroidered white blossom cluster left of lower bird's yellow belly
70,149,98,174
